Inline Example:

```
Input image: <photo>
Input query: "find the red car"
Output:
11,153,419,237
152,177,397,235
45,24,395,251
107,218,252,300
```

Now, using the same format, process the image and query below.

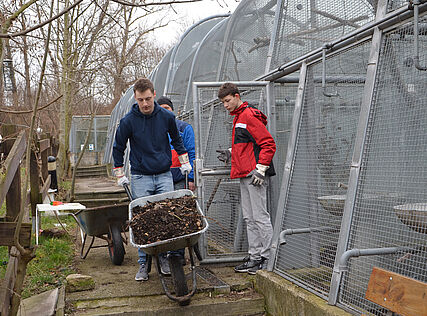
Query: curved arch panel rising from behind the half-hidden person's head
164,17,224,113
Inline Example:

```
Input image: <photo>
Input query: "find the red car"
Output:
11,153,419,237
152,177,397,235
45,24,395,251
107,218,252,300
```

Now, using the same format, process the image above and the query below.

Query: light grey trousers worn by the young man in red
240,177,273,260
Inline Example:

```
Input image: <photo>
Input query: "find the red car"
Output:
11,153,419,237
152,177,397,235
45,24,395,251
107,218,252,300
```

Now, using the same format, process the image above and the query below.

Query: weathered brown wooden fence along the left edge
0,125,52,315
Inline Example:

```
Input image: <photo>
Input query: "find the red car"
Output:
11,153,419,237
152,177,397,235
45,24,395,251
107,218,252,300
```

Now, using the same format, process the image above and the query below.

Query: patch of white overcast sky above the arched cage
148,0,240,46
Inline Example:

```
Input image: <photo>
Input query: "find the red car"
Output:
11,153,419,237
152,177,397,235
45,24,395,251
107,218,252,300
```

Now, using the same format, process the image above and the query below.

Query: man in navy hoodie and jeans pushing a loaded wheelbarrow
113,78,192,281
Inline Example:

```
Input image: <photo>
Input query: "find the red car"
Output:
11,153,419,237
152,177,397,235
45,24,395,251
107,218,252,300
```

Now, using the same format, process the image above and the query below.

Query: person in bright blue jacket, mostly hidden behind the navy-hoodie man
157,96,196,191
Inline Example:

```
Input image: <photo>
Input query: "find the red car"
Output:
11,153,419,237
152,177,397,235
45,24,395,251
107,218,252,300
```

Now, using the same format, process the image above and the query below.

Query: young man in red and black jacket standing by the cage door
217,82,276,274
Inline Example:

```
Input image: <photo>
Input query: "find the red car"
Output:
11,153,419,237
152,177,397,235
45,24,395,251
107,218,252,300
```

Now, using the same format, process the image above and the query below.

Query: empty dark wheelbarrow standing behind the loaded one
75,203,128,265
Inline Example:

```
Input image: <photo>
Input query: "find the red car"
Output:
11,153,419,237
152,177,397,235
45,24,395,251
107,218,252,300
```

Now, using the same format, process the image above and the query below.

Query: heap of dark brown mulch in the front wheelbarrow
130,196,203,245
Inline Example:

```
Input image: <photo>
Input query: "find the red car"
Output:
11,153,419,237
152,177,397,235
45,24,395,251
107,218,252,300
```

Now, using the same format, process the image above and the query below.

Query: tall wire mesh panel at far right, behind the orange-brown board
339,17,427,315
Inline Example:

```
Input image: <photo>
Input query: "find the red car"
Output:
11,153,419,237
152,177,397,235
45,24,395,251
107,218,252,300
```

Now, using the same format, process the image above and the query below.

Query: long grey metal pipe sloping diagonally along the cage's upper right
255,4,427,81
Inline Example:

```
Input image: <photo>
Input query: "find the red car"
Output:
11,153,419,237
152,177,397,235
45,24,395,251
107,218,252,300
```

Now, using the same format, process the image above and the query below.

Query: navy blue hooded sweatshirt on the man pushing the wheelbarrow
113,102,186,175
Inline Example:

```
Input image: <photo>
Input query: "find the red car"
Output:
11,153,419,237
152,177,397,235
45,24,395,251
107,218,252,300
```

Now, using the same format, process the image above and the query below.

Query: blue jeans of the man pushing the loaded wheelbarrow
130,171,184,264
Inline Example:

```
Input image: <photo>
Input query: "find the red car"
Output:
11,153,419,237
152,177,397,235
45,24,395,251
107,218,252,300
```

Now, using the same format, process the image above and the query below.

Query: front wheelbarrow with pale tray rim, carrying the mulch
129,189,209,306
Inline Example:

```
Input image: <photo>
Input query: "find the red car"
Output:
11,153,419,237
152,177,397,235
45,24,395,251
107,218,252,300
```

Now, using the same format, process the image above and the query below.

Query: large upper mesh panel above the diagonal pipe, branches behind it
270,0,376,69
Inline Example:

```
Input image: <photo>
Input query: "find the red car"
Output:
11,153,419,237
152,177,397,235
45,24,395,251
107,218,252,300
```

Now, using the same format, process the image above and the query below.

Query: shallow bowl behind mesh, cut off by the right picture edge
393,203,427,234
